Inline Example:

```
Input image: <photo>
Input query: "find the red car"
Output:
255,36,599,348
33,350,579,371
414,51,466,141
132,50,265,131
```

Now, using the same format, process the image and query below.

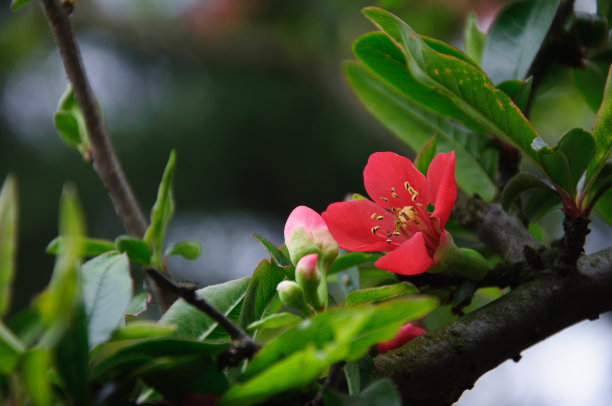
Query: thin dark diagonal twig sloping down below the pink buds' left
146,269,259,355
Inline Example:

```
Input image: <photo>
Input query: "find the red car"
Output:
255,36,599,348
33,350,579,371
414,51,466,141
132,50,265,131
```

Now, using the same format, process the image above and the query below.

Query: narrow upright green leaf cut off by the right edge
585,65,612,191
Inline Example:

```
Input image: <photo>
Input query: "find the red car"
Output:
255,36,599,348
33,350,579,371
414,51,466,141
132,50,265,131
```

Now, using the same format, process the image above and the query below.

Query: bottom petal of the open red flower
374,233,434,275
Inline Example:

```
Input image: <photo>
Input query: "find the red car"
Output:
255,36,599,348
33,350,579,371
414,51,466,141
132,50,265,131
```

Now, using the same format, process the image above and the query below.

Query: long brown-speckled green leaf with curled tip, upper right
364,7,539,170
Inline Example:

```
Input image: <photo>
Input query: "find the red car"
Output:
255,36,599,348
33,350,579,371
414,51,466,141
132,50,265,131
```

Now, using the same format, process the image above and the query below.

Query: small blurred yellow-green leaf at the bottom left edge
21,347,53,406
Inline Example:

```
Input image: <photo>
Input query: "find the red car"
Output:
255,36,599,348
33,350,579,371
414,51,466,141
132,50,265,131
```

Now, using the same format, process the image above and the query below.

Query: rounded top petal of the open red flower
363,152,430,210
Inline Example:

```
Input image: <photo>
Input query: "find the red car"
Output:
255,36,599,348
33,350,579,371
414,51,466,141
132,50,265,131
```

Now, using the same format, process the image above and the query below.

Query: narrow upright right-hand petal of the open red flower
427,151,457,228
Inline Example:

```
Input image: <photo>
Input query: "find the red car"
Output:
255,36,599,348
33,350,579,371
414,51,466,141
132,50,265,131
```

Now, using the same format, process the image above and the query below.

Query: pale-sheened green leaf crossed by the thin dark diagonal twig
159,278,251,340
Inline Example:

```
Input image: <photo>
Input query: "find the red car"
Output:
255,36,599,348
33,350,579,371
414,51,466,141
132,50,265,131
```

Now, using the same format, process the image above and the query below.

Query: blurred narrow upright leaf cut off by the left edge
0,175,18,318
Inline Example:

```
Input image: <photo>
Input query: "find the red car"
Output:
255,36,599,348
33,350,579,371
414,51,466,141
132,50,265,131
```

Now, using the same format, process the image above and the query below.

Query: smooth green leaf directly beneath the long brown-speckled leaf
353,32,482,133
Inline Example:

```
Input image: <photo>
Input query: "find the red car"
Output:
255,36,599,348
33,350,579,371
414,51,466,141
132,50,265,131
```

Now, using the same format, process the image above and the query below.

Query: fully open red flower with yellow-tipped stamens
322,152,457,275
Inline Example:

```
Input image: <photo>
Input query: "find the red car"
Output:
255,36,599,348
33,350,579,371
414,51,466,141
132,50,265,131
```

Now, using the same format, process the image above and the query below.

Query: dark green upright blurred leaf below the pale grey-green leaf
54,301,90,406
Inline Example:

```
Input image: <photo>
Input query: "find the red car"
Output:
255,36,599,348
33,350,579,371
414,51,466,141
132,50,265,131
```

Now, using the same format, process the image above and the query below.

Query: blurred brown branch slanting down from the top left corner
40,0,147,237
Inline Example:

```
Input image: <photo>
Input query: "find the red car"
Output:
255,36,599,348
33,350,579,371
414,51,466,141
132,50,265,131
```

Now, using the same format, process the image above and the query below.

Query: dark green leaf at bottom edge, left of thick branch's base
323,379,402,406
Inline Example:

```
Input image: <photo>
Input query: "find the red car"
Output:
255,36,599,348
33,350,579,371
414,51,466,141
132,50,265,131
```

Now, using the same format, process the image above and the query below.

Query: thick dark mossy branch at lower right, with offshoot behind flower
374,197,612,406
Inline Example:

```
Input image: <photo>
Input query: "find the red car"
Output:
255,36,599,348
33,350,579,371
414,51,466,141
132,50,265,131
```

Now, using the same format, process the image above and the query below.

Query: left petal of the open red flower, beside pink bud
322,199,406,251
